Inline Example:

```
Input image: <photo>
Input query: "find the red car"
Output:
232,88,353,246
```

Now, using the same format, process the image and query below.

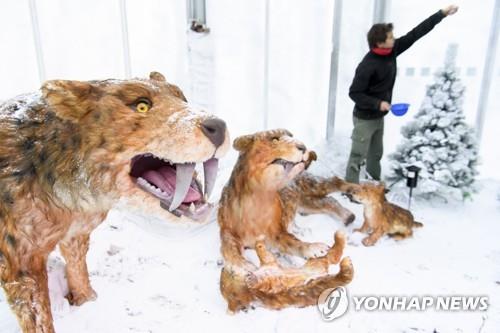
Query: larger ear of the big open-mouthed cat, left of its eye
41,80,103,121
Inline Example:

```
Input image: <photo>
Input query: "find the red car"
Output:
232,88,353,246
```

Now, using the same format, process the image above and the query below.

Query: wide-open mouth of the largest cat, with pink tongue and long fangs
130,153,218,220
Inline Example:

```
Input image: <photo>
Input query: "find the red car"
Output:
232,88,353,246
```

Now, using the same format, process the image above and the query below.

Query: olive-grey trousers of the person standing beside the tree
345,116,384,183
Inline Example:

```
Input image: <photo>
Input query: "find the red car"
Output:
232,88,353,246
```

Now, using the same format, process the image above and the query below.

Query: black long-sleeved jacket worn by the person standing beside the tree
349,10,445,119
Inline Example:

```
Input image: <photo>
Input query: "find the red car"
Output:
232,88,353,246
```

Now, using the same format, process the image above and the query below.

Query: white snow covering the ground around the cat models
0,139,500,333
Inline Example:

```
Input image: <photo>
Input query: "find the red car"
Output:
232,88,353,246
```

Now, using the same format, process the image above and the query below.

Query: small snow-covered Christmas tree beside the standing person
388,45,478,198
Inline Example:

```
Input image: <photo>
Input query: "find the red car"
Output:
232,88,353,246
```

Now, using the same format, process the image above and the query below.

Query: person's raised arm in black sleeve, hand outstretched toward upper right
394,5,458,56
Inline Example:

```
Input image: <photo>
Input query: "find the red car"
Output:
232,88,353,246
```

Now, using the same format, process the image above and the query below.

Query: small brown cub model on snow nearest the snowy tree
345,183,423,246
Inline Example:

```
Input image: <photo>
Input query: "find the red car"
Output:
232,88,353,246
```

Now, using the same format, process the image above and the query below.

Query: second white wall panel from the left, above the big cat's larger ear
36,0,124,80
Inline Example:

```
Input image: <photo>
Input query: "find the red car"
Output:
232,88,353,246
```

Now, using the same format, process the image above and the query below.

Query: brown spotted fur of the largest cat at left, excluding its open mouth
0,72,229,333
